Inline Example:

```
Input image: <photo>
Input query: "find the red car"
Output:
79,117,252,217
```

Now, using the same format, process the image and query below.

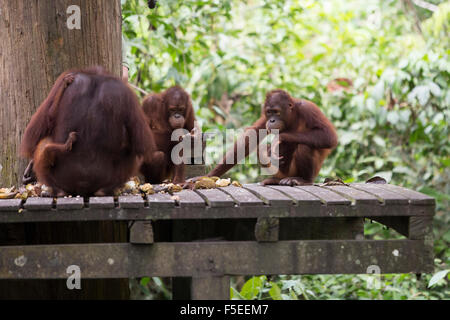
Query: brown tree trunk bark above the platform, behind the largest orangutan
0,0,122,186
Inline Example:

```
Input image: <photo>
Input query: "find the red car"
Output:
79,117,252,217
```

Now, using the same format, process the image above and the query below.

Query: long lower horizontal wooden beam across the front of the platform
0,239,434,279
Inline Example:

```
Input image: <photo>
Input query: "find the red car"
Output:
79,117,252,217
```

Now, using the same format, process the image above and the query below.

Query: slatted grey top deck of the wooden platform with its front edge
0,184,435,223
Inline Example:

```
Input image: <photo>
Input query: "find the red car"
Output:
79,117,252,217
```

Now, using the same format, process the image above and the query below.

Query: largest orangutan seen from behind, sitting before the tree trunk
21,67,155,196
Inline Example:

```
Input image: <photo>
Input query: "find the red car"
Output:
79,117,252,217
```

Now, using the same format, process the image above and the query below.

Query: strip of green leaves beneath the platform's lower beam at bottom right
232,270,450,300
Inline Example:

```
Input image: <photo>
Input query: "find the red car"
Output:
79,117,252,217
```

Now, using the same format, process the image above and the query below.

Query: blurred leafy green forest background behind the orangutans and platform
122,0,450,299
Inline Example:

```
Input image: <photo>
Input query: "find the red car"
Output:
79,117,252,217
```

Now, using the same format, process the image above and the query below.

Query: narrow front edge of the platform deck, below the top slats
0,202,434,223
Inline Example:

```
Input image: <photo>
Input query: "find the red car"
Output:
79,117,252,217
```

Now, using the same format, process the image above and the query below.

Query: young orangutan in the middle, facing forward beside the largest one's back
141,86,195,184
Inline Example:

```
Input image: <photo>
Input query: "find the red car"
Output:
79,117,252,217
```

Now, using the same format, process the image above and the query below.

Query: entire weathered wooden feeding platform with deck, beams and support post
0,184,435,298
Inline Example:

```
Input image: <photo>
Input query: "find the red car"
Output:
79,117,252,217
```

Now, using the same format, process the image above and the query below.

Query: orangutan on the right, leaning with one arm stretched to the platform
204,89,337,186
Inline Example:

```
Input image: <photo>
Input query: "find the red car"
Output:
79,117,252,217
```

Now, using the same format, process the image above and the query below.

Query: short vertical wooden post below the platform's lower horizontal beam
191,276,230,300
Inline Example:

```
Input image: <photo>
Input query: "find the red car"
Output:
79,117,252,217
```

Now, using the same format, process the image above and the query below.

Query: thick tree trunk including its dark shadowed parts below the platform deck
0,0,129,299
